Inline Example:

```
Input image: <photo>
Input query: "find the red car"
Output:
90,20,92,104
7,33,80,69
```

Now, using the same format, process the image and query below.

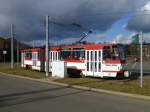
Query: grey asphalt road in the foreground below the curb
0,75,150,112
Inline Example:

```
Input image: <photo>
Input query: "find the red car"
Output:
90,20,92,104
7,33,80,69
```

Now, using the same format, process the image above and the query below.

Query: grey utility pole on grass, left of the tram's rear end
11,24,14,69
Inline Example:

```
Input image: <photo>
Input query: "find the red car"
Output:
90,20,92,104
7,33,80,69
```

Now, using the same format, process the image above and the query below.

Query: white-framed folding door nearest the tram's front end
85,50,101,76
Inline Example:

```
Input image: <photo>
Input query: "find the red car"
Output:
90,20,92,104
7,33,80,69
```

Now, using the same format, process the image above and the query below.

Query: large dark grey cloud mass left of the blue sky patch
0,0,145,41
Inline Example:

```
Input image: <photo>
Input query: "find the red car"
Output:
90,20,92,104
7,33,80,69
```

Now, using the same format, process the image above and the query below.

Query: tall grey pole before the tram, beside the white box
45,16,49,76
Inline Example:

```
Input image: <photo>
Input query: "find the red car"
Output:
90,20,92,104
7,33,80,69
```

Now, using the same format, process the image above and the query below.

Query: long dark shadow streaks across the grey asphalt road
0,86,85,108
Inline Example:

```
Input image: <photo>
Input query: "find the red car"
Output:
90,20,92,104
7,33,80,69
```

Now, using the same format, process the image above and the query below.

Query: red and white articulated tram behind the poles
21,44,128,77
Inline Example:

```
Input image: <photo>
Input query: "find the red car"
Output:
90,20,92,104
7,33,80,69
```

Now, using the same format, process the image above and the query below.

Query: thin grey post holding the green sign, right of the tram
140,32,143,88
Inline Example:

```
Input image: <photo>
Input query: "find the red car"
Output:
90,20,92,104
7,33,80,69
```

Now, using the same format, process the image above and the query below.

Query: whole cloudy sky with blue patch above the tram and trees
0,0,150,45
